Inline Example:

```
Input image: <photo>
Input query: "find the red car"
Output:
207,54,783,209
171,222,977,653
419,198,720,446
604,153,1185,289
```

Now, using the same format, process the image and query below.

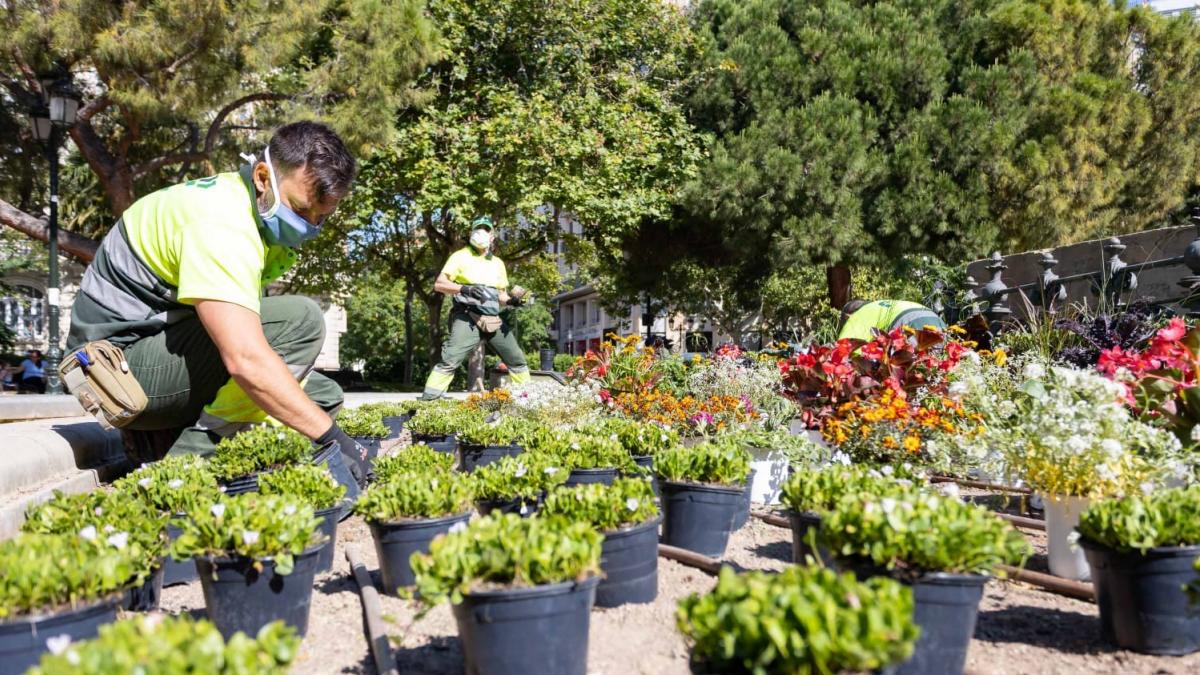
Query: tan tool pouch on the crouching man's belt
59,340,146,429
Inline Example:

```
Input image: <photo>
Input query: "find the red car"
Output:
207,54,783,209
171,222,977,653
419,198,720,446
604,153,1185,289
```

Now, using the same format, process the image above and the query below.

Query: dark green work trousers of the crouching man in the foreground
124,295,342,461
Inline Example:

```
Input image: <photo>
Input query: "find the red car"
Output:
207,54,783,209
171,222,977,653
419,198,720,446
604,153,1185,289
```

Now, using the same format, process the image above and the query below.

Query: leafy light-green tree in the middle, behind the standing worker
298,0,700,367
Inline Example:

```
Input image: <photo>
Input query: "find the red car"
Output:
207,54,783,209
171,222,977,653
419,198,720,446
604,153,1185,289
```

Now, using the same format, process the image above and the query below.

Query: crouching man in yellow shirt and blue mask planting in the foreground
67,121,366,497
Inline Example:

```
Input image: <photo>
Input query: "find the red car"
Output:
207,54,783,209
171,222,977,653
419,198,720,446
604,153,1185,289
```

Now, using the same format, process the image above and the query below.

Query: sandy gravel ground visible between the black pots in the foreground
163,502,1200,675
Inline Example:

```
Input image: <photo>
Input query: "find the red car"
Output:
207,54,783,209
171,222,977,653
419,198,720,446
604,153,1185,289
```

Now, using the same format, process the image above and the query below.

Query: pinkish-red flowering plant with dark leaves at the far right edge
1096,318,1200,444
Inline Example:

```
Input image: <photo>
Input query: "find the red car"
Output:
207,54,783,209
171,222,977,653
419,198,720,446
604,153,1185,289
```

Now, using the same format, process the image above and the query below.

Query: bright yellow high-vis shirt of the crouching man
121,167,296,312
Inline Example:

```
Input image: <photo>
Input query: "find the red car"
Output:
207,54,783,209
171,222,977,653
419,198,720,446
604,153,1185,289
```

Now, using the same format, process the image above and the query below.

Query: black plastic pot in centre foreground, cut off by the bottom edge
454,577,600,675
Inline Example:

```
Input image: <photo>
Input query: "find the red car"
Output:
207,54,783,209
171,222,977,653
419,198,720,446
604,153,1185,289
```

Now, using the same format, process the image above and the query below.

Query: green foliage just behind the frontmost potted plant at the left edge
20,482,167,581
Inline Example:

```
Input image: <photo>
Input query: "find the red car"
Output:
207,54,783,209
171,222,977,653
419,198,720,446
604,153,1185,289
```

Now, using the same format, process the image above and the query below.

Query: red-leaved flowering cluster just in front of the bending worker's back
779,328,967,429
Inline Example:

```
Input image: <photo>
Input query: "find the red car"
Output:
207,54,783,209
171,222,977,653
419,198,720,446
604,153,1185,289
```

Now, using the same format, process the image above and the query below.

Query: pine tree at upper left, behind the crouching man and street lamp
0,0,434,261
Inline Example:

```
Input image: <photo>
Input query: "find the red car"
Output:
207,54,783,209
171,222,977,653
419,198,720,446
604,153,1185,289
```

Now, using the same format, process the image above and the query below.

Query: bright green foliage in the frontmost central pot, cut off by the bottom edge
412,513,602,605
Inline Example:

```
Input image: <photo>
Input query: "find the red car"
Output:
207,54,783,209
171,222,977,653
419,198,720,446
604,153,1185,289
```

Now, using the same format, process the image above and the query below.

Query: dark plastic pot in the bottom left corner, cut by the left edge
0,593,126,675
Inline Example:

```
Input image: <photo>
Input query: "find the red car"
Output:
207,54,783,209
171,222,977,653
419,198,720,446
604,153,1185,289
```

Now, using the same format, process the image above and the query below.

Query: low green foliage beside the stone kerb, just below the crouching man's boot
113,455,221,515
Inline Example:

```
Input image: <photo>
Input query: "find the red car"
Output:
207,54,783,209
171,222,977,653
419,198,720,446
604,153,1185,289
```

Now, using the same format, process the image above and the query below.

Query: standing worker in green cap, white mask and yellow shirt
421,216,529,400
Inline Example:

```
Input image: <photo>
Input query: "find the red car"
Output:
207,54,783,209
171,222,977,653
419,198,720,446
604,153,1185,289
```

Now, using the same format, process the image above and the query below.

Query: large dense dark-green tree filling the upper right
600,0,1200,333
